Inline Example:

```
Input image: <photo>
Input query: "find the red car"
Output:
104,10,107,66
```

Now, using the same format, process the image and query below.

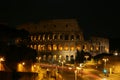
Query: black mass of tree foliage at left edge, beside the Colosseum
0,24,37,67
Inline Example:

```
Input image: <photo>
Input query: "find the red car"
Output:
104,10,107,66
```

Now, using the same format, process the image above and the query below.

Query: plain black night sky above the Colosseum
0,0,120,38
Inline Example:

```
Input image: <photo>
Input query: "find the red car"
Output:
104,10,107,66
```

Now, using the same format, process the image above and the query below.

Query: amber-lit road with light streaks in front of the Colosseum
37,64,120,80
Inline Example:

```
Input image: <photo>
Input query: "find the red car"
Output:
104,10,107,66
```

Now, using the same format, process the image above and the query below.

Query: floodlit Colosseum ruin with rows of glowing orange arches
18,19,109,61
